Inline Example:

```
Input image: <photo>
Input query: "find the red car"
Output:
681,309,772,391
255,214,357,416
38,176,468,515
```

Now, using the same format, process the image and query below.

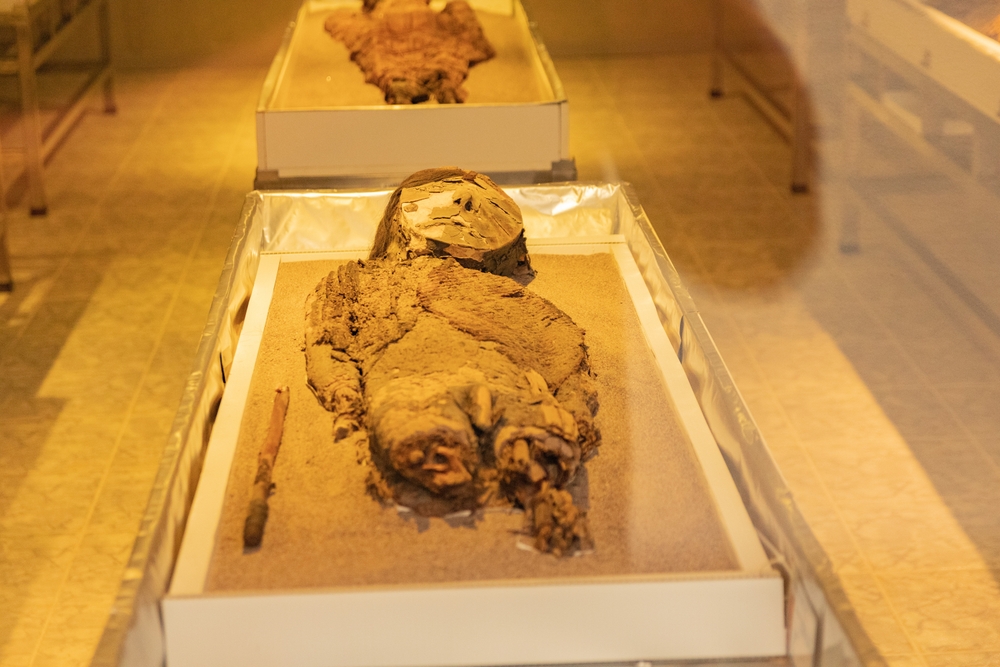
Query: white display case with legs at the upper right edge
845,0,1000,200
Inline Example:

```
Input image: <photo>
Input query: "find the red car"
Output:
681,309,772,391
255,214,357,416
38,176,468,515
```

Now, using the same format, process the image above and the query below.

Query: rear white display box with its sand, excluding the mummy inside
257,0,575,188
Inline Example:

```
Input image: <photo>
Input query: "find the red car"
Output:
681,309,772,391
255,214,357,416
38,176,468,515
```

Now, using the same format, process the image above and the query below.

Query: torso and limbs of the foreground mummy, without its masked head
305,256,600,554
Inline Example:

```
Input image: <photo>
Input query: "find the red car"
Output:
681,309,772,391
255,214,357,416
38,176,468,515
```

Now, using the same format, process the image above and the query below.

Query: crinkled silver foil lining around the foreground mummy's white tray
91,183,881,667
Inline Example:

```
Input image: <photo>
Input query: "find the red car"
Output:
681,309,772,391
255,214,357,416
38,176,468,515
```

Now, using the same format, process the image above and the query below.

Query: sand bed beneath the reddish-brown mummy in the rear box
269,2,555,110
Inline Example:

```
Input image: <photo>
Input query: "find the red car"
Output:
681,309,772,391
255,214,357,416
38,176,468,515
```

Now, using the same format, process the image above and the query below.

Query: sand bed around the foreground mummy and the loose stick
205,254,737,592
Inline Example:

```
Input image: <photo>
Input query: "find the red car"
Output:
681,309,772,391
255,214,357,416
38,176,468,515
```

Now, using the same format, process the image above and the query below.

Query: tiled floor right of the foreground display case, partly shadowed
560,57,1000,665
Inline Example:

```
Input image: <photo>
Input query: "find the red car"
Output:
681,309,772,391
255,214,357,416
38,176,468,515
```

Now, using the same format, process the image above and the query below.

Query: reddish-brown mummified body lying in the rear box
325,0,494,104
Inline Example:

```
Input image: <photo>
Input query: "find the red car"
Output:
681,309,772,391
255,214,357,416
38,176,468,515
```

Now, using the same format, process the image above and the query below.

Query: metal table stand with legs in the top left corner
0,0,116,215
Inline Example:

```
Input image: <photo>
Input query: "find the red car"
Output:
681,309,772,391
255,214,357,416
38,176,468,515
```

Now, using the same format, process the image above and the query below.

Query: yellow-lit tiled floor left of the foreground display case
0,65,263,667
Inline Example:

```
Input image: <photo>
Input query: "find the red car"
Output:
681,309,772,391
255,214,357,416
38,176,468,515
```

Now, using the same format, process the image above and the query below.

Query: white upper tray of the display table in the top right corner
847,0,1000,120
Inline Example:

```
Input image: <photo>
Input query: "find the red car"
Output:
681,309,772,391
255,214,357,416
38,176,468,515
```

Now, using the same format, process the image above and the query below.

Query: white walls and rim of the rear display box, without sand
257,0,576,188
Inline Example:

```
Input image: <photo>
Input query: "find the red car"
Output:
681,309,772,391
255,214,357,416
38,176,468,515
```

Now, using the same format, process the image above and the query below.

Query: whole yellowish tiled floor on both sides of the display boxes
0,55,1000,667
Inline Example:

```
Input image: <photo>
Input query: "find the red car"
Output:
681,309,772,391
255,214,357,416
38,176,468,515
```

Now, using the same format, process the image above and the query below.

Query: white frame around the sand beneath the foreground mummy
161,188,786,667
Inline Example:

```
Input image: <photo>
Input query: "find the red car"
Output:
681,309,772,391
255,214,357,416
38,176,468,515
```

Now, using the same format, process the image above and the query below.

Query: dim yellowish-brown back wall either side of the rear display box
105,0,711,69
